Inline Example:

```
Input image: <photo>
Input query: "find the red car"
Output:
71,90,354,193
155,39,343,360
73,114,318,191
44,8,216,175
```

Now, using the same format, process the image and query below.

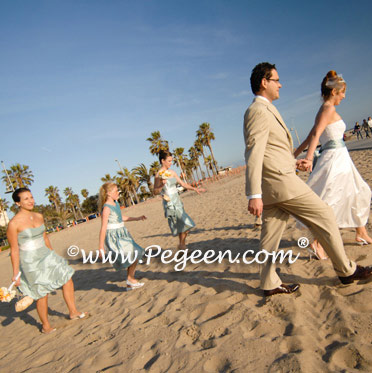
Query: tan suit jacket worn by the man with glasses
244,97,311,205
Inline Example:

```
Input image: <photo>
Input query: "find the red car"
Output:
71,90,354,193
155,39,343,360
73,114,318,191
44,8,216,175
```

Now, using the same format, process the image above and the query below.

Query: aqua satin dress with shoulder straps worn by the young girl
103,201,145,270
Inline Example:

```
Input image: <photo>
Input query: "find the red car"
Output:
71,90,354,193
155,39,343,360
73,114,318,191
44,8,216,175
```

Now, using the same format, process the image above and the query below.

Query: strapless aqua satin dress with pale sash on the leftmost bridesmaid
18,224,74,300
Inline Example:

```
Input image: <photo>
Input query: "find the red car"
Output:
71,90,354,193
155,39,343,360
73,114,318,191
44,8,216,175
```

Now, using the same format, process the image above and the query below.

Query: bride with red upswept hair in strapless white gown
294,70,372,259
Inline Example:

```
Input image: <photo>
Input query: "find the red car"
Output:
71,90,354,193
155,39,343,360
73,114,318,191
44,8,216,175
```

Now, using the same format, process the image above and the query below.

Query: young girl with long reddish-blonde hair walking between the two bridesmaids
98,182,146,290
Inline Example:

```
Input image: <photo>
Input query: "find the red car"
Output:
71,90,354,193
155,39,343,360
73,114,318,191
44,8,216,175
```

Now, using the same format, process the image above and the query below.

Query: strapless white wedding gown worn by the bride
307,119,371,228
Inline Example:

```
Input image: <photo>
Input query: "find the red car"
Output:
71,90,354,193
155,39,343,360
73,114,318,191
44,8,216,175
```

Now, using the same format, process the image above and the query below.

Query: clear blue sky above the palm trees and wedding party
0,0,372,204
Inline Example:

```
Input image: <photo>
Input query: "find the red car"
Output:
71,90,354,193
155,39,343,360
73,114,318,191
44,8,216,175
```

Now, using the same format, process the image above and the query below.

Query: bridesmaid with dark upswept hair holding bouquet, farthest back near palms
154,150,205,250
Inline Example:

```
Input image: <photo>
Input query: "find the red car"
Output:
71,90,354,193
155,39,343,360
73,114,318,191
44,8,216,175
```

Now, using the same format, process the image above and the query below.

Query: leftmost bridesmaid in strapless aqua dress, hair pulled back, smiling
7,188,88,334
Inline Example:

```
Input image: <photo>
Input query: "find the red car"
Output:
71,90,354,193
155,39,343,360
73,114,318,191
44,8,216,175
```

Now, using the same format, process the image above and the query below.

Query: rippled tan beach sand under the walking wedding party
0,150,372,373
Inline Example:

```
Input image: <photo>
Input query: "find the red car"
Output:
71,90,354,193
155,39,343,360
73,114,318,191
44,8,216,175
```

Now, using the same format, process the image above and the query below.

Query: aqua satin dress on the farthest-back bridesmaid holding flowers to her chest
163,177,195,236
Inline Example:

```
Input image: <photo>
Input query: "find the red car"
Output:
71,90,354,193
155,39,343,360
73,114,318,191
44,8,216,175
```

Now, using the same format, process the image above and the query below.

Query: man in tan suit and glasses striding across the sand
244,62,372,296
